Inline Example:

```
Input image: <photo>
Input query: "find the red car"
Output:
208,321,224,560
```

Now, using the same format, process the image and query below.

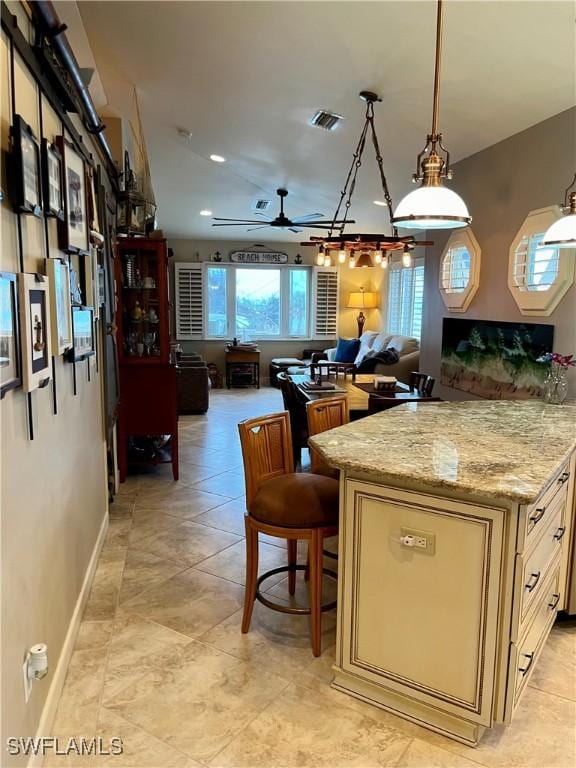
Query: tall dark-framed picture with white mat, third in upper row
56,136,88,253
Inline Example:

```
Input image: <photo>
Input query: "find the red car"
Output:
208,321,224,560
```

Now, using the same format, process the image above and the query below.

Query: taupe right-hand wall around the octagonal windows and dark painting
420,109,576,400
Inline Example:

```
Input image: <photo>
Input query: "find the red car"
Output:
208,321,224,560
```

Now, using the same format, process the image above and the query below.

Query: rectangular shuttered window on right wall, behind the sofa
387,262,424,339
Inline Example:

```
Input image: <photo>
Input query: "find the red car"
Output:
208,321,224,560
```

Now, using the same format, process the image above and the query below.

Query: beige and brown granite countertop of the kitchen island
310,400,576,503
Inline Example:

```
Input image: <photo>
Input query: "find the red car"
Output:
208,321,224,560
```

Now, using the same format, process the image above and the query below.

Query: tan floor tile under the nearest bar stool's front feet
200,602,336,680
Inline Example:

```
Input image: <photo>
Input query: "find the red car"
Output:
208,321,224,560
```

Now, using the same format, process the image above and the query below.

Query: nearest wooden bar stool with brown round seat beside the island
238,411,338,656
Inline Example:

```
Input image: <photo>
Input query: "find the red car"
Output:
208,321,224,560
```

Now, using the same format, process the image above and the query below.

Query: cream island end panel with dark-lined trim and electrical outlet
340,480,506,726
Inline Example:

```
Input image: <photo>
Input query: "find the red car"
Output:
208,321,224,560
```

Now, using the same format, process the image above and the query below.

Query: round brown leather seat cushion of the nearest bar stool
249,472,339,528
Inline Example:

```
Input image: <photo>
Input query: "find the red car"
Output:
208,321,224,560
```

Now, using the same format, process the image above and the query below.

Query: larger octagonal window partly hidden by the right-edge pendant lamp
508,206,575,316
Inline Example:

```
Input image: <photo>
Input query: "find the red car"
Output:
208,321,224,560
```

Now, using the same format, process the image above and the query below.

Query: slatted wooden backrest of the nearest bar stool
238,411,294,509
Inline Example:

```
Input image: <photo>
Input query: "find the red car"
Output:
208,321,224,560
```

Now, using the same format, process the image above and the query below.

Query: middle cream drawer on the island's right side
513,499,566,639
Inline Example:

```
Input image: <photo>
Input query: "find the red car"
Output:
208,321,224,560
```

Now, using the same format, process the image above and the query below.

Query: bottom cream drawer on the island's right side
506,566,560,720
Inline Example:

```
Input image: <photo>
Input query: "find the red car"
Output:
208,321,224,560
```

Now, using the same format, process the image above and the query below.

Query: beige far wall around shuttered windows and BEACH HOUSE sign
168,234,384,381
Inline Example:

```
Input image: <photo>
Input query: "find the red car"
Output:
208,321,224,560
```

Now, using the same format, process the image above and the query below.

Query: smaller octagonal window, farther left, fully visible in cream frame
439,227,480,312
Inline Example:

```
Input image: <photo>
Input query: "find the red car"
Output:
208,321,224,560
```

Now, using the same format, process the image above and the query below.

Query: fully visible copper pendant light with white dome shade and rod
392,0,472,229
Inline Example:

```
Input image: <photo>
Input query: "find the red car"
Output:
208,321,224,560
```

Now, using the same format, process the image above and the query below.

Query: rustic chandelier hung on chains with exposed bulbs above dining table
302,91,432,269
